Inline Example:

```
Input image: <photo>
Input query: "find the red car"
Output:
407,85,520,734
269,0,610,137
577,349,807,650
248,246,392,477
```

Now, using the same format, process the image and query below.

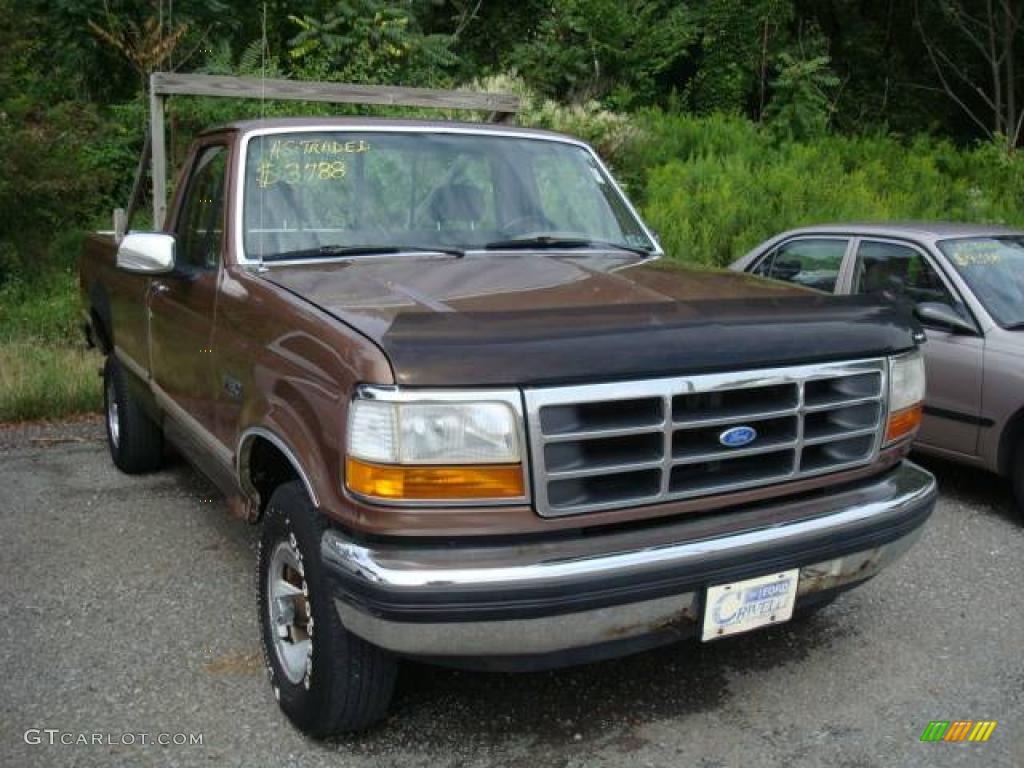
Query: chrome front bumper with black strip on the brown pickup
322,462,936,659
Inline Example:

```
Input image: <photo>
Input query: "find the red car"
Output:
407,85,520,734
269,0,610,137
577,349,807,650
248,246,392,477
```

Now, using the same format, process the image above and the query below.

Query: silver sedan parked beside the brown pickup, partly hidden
731,222,1024,520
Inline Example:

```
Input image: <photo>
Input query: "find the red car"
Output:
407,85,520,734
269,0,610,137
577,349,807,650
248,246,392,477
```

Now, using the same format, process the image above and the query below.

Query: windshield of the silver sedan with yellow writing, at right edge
939,237,1024,328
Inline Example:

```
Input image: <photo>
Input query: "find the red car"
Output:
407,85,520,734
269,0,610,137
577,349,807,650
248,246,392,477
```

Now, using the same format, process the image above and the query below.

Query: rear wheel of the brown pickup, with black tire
103,355,164,475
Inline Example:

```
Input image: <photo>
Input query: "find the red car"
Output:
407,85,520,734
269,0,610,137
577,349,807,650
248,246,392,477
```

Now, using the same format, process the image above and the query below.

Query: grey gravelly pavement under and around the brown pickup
0,420,1024,768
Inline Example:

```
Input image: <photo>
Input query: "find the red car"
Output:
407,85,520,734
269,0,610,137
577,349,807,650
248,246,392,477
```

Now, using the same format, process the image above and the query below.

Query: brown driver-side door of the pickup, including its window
150,144,227,450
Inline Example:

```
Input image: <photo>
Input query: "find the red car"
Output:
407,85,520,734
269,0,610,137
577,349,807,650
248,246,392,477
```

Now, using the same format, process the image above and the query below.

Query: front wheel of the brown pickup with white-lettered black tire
257,481,396,738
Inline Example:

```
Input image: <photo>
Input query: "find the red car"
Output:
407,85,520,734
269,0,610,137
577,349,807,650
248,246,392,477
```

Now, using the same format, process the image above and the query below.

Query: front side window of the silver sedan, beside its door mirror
853,241,957,306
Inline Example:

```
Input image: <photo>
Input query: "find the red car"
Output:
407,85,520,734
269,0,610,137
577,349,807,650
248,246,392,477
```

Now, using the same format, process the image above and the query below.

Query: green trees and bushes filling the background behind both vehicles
0,0,1024,420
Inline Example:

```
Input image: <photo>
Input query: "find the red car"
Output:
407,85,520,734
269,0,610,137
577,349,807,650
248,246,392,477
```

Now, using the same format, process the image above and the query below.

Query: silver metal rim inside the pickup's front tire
266,537,313,688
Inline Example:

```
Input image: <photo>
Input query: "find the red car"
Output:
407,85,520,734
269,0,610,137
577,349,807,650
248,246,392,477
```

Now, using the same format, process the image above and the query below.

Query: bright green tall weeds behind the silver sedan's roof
627,113,1024,266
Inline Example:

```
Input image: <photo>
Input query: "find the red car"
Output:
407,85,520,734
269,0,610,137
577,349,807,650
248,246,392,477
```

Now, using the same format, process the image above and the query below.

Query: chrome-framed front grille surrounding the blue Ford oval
525,359,888,517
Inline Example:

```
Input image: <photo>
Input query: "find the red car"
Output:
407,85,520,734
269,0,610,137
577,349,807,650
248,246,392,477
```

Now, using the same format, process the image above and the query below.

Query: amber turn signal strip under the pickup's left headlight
345,457,525,501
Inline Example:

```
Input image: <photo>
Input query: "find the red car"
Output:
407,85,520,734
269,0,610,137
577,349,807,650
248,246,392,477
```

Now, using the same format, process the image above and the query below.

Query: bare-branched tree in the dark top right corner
914,0,1024,150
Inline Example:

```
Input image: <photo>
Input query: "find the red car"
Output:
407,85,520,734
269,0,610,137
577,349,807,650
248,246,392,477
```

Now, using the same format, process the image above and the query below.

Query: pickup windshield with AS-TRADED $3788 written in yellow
244,131,654,259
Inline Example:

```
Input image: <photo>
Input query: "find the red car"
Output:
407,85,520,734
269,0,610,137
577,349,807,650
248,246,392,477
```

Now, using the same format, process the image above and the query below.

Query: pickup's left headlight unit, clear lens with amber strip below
345,394,525,502
